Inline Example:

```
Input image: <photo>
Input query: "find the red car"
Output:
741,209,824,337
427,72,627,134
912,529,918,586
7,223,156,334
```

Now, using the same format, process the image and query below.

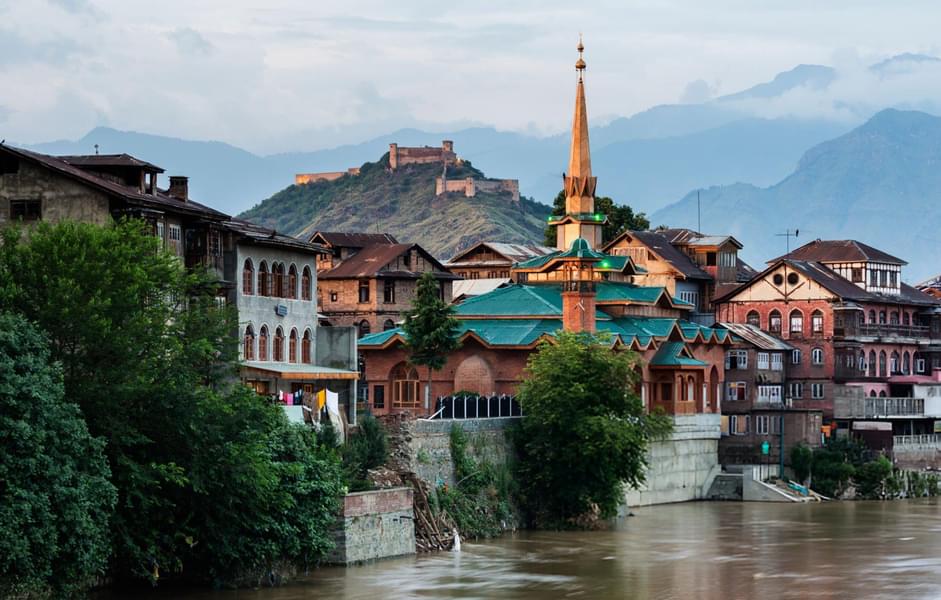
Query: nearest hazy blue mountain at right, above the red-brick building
651,109,941,282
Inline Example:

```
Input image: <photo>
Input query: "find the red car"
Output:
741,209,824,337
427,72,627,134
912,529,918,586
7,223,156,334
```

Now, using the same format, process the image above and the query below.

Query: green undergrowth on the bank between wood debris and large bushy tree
436,423,515,538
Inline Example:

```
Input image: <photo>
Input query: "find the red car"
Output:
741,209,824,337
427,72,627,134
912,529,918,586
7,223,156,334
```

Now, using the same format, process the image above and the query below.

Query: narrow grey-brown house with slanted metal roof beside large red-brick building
719,323,823,465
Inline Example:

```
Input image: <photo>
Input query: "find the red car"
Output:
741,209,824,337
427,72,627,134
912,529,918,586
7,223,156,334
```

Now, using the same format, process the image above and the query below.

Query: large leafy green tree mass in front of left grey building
0,222,342,585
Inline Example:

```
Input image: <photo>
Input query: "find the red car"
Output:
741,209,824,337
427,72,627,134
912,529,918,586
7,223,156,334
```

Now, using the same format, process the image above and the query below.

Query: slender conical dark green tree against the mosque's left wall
402,272,460,408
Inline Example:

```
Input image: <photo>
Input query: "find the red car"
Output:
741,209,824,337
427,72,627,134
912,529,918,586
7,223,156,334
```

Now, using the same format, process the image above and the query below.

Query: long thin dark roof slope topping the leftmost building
0,144,229,220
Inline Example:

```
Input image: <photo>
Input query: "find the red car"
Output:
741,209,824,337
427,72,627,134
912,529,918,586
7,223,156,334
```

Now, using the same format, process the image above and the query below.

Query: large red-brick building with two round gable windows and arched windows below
716,240,941,434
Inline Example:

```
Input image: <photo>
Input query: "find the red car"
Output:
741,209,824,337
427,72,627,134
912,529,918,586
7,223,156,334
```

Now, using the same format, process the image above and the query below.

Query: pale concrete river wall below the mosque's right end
626,414,721,506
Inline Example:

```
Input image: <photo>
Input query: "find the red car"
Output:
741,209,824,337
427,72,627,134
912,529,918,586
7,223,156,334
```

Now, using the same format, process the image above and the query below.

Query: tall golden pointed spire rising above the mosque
550,38,607,250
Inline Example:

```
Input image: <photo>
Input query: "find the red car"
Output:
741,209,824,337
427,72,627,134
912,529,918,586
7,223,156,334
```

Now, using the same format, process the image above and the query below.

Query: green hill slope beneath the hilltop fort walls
240,154,549,258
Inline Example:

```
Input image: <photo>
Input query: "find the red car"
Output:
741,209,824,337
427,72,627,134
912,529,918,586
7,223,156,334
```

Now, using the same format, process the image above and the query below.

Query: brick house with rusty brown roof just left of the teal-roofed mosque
310,232,458,336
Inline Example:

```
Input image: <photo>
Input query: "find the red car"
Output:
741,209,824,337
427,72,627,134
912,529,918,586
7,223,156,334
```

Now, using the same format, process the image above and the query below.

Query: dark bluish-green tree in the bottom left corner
0,313,115,598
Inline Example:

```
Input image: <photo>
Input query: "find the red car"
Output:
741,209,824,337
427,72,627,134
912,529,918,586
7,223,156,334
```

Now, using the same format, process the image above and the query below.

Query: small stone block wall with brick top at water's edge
327,488,415,565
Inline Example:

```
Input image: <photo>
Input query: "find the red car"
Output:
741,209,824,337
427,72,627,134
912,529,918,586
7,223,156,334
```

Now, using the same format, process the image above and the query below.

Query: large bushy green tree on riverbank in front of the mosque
514,332,672,526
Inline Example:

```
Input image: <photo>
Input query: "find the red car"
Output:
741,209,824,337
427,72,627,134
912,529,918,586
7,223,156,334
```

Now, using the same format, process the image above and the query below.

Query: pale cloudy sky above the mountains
0,0,941,153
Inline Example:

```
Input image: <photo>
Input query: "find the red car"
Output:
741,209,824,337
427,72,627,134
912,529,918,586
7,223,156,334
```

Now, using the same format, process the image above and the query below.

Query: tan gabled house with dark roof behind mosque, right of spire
604,229,755,326
